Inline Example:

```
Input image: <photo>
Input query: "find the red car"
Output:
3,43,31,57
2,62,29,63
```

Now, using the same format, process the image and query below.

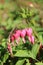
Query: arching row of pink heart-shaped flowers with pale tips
10,28,35,44
